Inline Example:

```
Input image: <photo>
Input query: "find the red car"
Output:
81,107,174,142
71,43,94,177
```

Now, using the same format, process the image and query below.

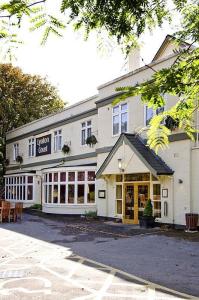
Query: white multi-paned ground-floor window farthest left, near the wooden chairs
5,175,34,201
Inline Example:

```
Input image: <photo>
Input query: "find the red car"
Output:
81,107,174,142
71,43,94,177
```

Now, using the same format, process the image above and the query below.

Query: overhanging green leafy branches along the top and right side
0,0,199,151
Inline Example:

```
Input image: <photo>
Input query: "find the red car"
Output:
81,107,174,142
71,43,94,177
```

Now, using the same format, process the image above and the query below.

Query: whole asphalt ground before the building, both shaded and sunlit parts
0,215,199,300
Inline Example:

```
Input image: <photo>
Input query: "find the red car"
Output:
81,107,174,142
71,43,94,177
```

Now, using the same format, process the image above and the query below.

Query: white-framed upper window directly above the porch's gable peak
113,103,128,135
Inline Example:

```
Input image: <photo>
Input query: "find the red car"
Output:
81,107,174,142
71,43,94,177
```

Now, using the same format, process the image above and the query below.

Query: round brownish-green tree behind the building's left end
0,64,64,195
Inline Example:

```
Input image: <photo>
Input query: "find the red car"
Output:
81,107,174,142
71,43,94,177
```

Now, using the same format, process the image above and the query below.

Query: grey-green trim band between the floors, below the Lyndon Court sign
7,152,96,171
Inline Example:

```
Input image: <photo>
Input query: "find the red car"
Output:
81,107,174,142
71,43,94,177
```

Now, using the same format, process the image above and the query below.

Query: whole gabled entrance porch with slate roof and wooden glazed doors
96,134,173,224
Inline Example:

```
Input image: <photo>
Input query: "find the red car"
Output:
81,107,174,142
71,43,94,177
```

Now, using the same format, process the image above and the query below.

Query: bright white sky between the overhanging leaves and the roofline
8,2,174,104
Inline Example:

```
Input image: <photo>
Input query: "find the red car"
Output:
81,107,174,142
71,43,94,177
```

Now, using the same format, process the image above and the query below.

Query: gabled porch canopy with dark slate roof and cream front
96,133,174,178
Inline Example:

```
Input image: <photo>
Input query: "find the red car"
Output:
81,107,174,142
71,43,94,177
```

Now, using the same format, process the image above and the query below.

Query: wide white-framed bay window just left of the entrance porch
43,170,95,205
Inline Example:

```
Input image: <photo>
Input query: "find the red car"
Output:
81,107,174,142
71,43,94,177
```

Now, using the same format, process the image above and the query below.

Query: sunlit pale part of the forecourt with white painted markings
0,227,198,300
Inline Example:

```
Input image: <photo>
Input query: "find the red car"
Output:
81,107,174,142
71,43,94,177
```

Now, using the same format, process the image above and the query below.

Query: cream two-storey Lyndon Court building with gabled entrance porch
5,35,199,225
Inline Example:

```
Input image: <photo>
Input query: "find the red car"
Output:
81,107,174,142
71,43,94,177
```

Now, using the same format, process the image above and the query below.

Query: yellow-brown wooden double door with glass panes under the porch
123,183,150,224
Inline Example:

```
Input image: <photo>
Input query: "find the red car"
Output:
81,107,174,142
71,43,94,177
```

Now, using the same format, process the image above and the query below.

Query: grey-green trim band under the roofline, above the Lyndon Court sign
6,108,97,144
